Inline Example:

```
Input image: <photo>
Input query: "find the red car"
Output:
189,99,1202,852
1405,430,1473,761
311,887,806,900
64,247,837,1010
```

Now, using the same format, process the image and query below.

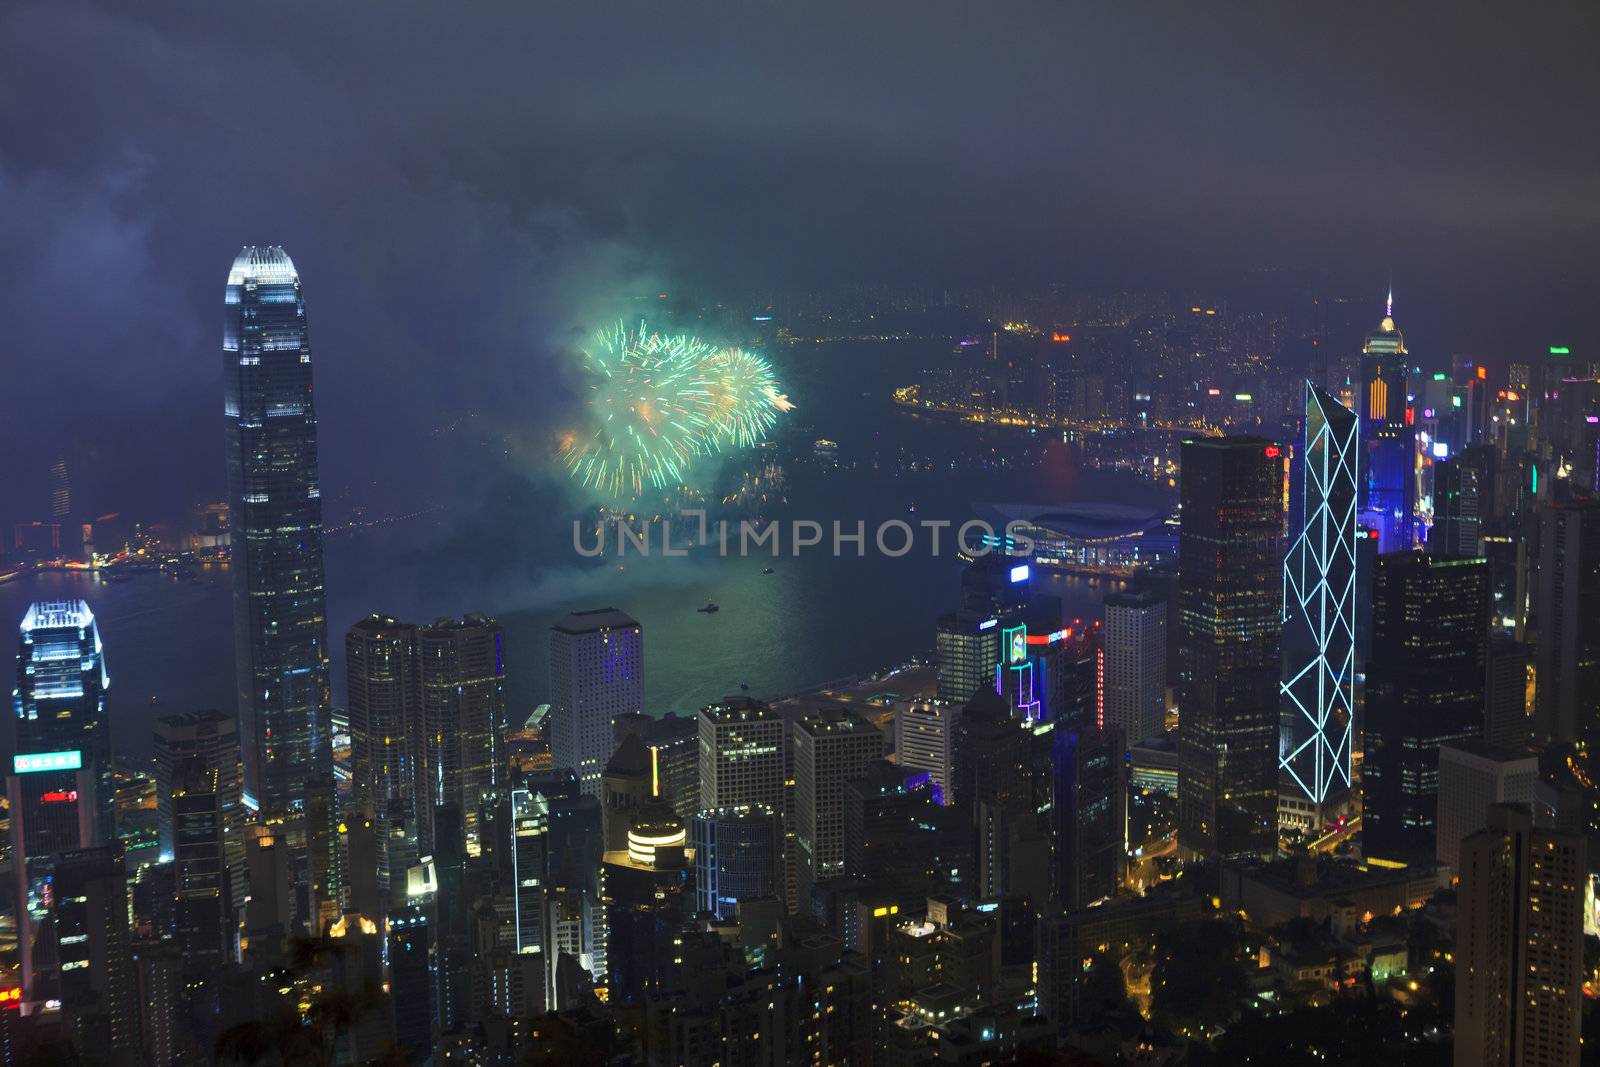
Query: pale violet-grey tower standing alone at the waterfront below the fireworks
550,608,645,797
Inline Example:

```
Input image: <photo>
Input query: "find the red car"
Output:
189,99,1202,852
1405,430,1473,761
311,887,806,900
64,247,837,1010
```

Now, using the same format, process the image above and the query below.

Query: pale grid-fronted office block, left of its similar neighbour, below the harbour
698,697,786,811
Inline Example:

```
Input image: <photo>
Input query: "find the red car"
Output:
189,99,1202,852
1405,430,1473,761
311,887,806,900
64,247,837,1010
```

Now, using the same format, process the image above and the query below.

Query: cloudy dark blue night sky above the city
0,0,1600,517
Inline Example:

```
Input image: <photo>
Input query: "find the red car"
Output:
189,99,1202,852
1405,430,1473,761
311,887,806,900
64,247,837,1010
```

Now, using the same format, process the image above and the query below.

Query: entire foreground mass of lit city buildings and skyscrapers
0,248,1600,1067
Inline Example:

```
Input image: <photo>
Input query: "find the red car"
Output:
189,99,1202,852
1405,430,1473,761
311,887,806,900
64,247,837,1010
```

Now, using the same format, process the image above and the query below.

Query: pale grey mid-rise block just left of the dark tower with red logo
1101,589,1168,744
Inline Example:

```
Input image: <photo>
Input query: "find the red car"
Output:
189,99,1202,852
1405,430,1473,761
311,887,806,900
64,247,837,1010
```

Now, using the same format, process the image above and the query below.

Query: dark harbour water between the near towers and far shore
0,337,1160,758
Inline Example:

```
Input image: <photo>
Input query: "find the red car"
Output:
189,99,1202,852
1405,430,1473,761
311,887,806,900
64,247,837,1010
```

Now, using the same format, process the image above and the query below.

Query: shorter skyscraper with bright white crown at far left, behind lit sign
14,600,117,845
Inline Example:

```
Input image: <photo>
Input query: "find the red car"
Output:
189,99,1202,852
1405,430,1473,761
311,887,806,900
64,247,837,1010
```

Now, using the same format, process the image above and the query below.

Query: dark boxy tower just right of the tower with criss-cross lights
1362,552,1490,857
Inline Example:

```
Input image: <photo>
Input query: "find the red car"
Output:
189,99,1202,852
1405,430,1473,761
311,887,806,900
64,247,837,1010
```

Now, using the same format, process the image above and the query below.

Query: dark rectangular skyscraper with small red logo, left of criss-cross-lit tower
1178,437,1285,856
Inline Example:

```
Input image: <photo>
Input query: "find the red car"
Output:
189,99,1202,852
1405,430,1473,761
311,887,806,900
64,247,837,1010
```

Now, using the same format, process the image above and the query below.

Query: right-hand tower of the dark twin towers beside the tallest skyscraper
416,614,506,854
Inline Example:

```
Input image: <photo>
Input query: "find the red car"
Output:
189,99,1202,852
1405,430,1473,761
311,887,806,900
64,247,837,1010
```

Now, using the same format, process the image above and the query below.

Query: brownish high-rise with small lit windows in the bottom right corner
1454,805,1584,1067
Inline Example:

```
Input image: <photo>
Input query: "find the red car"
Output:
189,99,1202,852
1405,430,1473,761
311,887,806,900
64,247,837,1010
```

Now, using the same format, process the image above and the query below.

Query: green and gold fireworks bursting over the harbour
562,323,794,499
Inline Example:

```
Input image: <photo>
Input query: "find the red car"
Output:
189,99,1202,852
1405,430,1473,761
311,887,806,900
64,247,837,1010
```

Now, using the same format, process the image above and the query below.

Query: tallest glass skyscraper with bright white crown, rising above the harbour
222,245,333,821
